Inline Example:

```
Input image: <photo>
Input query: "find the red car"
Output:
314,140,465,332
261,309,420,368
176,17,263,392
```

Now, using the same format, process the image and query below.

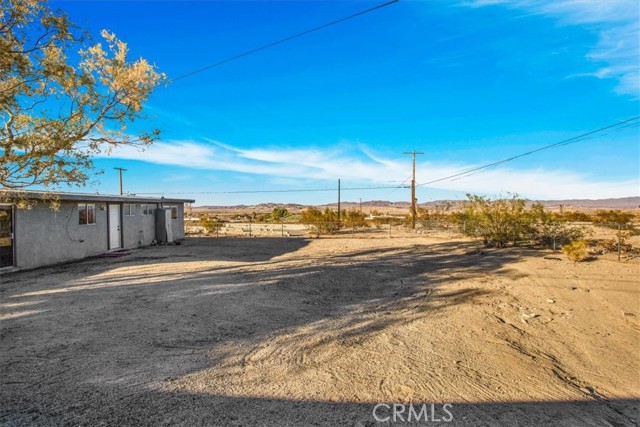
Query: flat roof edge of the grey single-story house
0,189,195,203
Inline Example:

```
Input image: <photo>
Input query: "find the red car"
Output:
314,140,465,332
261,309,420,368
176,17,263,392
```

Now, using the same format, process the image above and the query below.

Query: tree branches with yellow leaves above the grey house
0,0,165,189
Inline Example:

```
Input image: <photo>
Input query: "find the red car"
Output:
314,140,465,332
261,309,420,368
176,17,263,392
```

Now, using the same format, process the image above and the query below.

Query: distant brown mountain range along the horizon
194,197,640,212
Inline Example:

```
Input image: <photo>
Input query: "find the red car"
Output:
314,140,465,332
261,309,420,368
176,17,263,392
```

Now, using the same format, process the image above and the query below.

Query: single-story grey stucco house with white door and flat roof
0,190,194,269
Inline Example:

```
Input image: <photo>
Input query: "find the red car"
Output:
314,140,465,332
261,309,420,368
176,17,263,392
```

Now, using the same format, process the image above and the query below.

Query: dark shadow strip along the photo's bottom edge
0,388,640,427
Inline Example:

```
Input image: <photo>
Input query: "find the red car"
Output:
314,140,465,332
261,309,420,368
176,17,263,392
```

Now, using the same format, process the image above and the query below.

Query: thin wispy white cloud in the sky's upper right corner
461,0,640,98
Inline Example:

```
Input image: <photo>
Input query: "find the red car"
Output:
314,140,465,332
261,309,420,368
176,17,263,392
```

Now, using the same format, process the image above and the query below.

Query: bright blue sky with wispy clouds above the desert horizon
52,0,640,205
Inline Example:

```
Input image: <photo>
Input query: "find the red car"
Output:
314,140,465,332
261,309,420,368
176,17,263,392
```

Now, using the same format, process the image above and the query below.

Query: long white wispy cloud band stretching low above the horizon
97,140,640,199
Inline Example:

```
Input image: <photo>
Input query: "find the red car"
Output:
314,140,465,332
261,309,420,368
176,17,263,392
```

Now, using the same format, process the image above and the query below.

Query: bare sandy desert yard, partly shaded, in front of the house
0,235,640,427
